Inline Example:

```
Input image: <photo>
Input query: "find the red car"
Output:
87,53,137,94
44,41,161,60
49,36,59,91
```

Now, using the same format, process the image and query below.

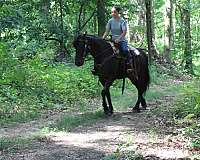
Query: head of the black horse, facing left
73,34,88,66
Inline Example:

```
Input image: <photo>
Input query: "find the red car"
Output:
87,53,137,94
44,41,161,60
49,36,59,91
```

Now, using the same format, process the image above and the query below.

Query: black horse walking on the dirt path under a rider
73,34,150,115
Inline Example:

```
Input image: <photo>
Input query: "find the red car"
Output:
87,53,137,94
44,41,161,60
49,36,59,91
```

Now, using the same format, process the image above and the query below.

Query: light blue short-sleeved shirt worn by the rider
106,18,127,41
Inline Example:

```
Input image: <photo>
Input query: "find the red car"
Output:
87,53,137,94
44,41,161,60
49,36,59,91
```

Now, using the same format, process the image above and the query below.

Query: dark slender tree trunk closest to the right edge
183,0,194,74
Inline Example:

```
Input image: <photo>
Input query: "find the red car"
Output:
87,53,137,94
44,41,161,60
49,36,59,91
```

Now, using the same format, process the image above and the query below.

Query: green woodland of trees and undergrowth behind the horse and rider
0,0,200,159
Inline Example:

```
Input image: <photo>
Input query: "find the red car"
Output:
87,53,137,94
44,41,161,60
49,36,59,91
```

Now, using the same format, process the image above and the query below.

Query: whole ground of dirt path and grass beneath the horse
0,78,200,160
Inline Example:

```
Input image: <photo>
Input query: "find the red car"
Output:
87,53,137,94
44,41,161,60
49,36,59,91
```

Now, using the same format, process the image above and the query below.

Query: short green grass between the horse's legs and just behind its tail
110,81,183,111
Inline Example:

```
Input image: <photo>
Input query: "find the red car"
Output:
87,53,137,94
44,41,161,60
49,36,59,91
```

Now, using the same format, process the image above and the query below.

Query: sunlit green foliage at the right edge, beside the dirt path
172,80,200,150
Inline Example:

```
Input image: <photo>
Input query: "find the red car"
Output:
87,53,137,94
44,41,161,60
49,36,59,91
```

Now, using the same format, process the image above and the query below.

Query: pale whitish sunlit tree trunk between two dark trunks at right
164,0,174,63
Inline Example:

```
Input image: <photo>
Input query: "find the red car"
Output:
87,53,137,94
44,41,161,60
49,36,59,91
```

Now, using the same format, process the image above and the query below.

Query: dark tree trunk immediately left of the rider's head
97,0,106,36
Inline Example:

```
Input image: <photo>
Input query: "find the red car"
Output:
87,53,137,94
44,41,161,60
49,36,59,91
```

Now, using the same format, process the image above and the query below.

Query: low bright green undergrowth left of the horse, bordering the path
0,43,99,123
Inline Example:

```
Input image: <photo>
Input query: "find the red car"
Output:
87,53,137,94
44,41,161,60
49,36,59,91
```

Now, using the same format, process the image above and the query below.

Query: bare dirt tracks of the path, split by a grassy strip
0,96,194,160
